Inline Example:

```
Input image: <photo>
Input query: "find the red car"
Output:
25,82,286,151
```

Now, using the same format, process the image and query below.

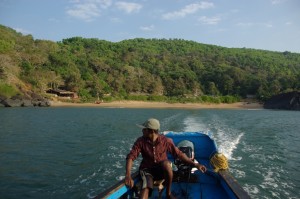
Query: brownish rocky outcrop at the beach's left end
0,93,50,107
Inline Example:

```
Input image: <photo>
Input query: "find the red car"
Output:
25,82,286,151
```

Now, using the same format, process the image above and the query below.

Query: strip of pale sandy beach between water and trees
51,101,263,109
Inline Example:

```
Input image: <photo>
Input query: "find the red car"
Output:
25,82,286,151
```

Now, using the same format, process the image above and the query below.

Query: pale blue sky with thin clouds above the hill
0,0,300,53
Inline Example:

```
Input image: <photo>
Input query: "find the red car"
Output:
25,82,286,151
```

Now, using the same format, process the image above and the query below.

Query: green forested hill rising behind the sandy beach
0,23,300,100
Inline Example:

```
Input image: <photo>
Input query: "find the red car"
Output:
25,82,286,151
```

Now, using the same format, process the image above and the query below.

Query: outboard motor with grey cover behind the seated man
174,140,194,176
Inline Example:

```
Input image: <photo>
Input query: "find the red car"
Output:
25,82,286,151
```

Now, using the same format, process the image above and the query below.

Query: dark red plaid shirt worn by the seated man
126,134,183,169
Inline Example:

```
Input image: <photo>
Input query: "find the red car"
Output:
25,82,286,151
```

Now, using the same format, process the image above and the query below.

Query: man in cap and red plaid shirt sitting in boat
125,118,206,198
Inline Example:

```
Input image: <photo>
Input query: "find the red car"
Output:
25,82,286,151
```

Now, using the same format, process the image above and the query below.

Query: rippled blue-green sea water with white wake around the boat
0,108,300,198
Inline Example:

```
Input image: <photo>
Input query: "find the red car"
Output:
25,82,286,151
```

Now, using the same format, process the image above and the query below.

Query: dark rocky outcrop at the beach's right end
264,91,300,110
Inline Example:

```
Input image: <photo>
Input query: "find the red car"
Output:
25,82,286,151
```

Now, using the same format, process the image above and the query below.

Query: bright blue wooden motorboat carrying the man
95,131,250,199
